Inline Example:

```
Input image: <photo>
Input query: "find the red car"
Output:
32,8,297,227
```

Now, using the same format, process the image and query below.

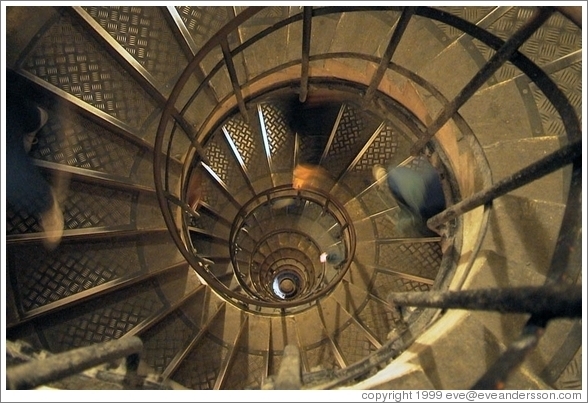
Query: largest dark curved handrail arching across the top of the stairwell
154,6,581,388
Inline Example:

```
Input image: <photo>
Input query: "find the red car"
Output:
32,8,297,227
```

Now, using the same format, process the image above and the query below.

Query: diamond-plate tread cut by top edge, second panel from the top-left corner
82,6,188,92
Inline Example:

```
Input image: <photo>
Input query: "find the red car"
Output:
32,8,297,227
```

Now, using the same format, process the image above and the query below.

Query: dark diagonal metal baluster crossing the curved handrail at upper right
410,7,555,156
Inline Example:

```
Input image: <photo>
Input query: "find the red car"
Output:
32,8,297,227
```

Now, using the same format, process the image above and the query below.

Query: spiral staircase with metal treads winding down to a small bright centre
5,6,582,390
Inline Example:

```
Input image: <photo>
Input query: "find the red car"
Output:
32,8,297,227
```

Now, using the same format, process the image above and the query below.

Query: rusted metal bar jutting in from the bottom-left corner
6,337,143,390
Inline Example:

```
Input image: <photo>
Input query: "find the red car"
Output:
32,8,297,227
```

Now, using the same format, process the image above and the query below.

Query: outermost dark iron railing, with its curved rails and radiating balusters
154,6,581,388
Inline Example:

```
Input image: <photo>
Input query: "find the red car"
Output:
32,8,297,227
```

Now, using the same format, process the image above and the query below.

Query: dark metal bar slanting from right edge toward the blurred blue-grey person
427,140,582,230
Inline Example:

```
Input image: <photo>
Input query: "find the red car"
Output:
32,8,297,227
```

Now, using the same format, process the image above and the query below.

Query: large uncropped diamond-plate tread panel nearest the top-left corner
23,9,157,128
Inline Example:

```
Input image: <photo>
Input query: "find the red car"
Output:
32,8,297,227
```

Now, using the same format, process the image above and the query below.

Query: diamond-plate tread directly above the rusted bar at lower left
34,280,167,353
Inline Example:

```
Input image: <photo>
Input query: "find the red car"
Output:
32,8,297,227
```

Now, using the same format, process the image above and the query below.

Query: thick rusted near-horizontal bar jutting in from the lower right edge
388,285,582,319
